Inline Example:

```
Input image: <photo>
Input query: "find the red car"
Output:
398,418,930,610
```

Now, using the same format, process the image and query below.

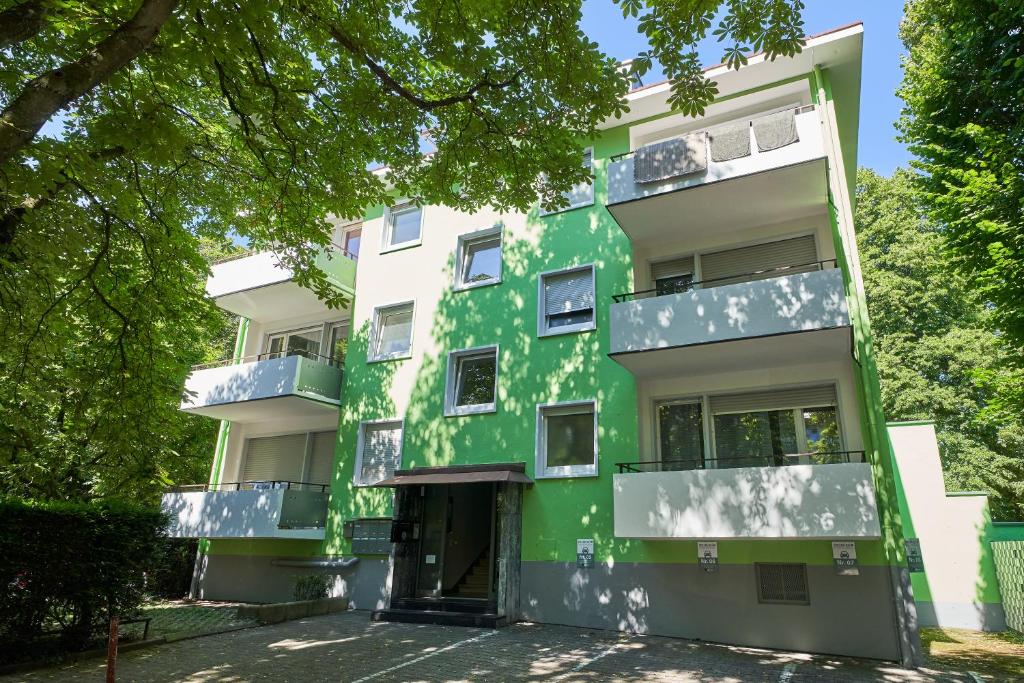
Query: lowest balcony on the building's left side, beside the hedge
160,481,330,540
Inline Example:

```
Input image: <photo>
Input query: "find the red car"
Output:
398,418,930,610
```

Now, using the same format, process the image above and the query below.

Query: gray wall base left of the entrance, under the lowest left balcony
198,555,388,609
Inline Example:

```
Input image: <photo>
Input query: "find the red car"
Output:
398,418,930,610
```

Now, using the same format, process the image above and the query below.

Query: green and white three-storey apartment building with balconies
164,25,916,663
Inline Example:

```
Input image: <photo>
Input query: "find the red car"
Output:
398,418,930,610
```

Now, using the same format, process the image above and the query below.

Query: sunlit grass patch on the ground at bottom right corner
921,629,1024,681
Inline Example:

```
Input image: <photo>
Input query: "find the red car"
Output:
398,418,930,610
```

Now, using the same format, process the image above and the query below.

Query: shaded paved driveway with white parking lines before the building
8,612,973,683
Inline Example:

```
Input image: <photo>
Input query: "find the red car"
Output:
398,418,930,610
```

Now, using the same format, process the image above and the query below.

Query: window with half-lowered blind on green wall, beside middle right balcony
537,265,596,337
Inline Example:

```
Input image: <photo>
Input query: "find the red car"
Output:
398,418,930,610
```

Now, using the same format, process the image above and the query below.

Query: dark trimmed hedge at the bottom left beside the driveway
0,499,166,661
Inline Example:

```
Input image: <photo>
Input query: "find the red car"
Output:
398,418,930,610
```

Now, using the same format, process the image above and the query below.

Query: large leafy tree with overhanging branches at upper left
0,0,803,498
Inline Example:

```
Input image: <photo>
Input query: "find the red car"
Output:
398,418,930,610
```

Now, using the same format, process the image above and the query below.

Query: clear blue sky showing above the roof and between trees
583,0,909,175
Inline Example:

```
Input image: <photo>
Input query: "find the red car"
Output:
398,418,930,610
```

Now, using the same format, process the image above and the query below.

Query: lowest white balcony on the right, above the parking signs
612,452,882,541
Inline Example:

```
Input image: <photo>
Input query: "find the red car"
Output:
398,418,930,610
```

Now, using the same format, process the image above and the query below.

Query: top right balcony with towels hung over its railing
608,105,828,246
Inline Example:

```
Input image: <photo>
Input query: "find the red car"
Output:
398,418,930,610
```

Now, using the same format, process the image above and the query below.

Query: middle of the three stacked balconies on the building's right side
608,261,851,377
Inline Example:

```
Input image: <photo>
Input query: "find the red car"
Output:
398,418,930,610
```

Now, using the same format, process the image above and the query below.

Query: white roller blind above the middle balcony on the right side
700,234,818,287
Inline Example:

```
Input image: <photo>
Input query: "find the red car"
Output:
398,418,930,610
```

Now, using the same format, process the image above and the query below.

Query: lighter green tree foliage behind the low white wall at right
857,169,1024,519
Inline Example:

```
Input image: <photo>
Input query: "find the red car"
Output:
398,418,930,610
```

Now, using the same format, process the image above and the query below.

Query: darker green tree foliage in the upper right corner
899,0,1024,352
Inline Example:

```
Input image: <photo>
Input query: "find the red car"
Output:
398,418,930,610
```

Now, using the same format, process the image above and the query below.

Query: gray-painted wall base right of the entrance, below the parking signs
520,562,900,660
